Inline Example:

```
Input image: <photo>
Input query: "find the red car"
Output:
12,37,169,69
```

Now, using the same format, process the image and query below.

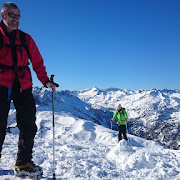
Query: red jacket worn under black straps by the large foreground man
0,22,49,90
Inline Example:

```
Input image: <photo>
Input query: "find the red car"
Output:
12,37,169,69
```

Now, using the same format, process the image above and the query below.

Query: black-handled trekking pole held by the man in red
50,75,59,180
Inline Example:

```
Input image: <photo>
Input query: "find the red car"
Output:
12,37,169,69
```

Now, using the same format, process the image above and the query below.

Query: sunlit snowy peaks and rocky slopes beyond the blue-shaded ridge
72,88,180,149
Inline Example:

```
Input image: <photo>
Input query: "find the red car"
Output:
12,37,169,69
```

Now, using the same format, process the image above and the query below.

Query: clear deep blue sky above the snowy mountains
0,0,180,90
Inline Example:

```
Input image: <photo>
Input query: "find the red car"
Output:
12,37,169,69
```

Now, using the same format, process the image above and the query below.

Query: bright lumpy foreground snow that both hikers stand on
0,110,180,180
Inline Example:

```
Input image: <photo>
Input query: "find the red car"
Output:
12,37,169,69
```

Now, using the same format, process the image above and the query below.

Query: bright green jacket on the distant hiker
112,108,128,125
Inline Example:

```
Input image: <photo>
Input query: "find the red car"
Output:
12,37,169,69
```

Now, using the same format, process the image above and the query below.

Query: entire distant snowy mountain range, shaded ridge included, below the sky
30,87,180,149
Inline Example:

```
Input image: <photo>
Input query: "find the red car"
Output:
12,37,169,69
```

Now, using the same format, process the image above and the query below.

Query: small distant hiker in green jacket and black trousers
110,104,128,142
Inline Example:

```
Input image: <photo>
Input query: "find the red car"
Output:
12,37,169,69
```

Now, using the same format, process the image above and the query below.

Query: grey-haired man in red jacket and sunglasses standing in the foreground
0,3,56,176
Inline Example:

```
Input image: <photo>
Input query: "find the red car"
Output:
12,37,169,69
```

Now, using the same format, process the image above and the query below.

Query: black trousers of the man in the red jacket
0,84,37,165
